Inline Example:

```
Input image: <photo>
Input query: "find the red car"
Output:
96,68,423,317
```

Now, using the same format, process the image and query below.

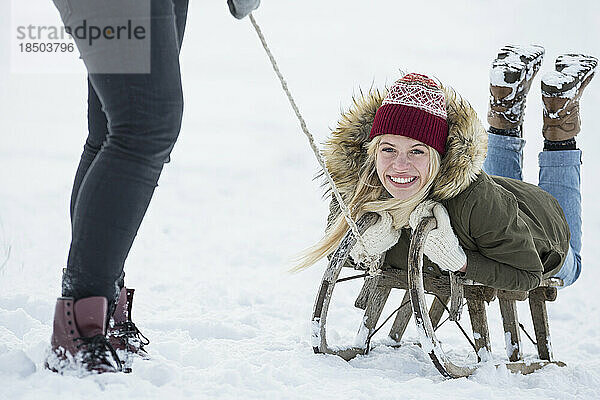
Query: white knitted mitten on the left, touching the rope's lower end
350,211,400,264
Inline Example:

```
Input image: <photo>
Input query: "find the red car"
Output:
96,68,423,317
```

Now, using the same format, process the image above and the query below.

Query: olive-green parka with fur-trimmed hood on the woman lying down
324,87,570,290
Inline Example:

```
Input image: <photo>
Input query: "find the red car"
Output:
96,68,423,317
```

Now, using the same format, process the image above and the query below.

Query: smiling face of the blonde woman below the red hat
376,134,429,200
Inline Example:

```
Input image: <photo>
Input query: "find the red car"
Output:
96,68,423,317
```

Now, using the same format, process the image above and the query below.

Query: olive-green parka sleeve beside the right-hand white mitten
462,186,543,290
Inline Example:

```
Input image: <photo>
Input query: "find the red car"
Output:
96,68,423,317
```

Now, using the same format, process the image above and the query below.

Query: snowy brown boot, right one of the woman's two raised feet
542,54,598,141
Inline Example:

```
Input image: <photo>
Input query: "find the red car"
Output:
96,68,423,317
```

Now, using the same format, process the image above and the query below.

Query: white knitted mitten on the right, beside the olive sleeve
409,200,467,272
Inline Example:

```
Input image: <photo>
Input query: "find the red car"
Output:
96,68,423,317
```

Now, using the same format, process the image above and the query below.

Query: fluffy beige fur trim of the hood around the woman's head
323,86,487,201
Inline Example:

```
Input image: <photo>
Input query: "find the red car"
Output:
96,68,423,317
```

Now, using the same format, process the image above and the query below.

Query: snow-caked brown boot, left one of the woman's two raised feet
488,45,544,130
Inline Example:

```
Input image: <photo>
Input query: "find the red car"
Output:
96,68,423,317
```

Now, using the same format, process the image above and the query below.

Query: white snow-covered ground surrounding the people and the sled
0,0,600,399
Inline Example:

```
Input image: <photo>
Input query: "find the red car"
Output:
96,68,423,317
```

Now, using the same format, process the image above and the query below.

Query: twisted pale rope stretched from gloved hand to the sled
249,14,379,275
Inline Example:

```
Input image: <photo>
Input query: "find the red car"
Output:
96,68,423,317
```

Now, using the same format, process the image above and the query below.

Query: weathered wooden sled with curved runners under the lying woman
311,213,565,378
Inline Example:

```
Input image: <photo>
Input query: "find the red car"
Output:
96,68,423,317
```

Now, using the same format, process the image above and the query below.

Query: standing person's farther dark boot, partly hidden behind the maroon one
107,287,150,364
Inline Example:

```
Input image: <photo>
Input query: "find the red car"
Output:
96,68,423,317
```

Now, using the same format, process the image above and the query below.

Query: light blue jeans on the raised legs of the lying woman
483,133,581,286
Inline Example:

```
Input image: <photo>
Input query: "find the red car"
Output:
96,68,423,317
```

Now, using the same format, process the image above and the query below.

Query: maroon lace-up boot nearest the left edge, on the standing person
46,296,121,374
